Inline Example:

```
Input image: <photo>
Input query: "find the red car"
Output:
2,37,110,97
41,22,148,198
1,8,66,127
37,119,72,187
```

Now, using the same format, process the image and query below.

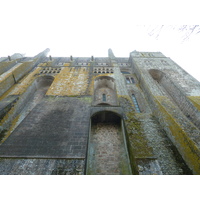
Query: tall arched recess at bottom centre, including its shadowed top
86,111,131,175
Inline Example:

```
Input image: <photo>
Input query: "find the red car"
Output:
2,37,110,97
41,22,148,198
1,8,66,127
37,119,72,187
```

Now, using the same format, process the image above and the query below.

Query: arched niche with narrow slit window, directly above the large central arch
93,76,118,106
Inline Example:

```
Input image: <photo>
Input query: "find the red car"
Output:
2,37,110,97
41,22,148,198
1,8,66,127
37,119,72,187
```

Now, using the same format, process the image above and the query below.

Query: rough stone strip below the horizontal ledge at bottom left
0,158,85,175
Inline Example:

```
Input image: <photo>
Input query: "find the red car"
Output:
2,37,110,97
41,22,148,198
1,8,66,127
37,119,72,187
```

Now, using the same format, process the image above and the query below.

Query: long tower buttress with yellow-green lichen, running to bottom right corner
132,54,200,174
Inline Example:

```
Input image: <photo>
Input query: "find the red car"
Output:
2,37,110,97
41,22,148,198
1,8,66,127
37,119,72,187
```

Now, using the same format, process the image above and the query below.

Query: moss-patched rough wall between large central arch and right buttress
120,93,192,174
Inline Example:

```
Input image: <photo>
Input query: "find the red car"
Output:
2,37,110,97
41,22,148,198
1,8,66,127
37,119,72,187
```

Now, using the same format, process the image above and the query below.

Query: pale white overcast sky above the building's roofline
0,0,200,81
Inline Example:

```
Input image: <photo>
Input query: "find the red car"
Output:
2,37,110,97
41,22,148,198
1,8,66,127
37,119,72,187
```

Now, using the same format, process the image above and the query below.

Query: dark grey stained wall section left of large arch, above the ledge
0,98,89,158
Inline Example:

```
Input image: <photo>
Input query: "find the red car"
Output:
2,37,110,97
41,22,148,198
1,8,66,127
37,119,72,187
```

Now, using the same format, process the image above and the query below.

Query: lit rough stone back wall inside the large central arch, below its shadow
88,123,131,175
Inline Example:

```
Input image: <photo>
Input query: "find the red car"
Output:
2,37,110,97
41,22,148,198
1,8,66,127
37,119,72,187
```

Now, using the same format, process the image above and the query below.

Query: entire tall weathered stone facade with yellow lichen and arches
0,49,200,175
